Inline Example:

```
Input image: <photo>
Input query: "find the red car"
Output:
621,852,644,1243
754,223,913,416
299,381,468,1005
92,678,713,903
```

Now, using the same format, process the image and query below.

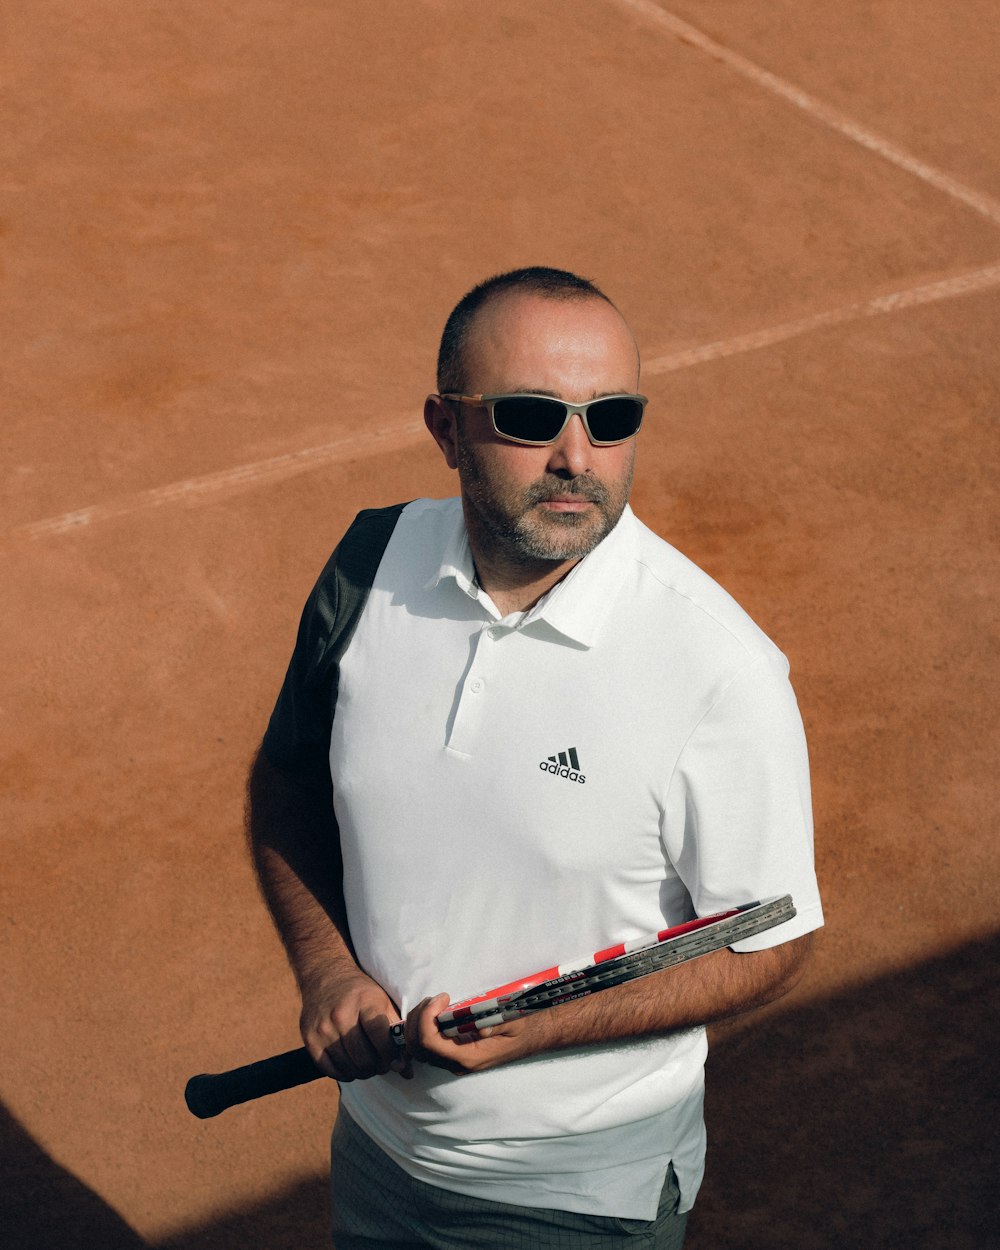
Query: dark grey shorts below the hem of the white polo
331,1111,688,1250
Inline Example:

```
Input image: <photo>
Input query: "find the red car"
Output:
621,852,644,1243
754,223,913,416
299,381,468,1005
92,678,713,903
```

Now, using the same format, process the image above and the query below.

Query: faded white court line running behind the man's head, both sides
8,263,1000,541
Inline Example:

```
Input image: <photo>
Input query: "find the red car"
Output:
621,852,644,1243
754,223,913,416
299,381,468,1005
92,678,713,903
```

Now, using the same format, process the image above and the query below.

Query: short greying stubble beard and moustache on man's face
456,435,633,566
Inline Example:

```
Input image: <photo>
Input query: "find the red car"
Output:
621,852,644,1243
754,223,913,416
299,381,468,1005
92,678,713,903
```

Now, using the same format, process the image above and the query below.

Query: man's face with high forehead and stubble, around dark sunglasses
455,294,639,565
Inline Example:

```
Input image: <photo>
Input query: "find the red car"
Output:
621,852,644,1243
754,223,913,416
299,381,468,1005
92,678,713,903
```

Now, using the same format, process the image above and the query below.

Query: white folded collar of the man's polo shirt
426,505,639,648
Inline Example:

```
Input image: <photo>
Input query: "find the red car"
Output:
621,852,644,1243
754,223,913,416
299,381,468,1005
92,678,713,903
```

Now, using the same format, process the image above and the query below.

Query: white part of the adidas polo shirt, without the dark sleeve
263,499,823,1219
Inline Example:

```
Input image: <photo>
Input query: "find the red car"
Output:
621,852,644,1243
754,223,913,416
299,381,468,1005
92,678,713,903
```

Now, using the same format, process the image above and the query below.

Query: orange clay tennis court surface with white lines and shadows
0,0,1000,1250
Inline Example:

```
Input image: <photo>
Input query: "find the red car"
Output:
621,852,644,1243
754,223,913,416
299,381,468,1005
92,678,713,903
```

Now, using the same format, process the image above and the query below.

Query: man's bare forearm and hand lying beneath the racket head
406,934,813,1073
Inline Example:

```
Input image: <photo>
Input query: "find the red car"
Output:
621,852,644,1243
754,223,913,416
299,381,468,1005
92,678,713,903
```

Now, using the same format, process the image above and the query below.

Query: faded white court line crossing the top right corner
616,0,1000,225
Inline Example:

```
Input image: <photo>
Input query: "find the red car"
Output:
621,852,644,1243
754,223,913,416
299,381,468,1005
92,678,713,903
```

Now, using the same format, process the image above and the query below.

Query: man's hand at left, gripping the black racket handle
299,971,413,1081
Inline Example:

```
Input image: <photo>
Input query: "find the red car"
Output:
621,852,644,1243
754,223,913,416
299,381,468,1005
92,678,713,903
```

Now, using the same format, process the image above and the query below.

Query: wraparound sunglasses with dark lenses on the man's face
441,393,649,448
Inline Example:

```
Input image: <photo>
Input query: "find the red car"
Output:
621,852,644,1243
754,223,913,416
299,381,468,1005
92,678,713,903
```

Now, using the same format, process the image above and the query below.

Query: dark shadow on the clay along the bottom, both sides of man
0,936,1000,1250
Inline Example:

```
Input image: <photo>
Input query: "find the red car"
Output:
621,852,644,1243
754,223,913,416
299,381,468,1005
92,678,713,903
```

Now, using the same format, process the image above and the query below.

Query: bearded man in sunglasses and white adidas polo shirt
250,269,823,1250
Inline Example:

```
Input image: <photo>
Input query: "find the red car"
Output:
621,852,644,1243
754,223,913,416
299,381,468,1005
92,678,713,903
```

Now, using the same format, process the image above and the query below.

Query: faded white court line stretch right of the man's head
643,265,1000,374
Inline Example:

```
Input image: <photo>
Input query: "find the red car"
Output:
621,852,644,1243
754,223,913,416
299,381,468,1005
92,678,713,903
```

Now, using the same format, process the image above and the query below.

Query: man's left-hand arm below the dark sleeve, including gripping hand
246,751,406,1081
